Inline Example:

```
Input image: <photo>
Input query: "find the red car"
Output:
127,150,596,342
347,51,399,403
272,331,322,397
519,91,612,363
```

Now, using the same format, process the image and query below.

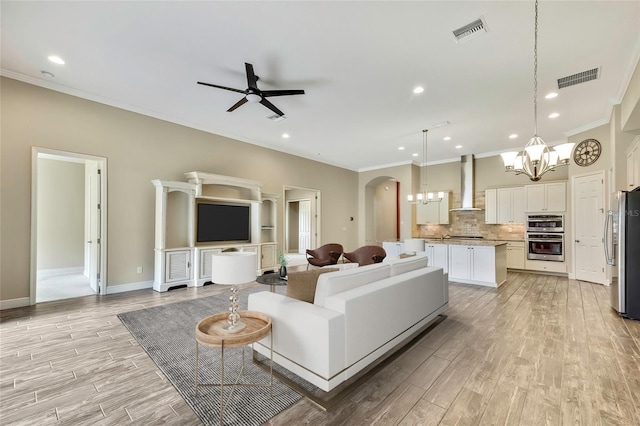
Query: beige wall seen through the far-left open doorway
37,158,85,271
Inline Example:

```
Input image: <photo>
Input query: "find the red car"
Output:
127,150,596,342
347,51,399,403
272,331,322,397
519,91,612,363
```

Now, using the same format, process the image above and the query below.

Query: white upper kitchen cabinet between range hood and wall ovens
485,186,525,224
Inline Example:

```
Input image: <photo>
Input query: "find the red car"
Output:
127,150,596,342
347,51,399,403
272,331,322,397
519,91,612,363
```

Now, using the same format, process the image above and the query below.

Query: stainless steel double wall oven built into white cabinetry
526,214,564,262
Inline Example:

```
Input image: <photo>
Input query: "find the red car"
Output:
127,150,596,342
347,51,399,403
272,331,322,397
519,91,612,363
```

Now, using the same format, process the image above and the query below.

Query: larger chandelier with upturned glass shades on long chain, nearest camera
500,0,574,182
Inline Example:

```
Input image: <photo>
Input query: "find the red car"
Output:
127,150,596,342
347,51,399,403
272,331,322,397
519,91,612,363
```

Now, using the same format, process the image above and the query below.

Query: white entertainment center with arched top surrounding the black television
151,172,278,291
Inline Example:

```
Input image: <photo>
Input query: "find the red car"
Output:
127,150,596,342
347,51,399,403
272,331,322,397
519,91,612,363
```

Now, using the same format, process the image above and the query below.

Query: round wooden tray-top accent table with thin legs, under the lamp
195,311,273,424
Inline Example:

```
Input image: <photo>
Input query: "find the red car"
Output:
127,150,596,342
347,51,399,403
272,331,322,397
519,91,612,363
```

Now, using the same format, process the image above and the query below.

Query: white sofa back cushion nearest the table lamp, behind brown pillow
313,263,391,306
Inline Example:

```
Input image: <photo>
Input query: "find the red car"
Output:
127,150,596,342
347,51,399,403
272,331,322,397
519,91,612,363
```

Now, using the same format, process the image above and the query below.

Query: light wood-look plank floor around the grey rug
0,273,640,426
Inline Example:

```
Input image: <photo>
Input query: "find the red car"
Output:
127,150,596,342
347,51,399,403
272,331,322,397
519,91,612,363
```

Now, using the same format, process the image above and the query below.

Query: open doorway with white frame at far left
30,148,106,304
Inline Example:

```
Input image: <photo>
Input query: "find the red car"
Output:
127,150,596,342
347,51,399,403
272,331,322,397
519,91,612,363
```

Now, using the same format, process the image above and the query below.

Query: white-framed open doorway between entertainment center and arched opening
284,187,320,263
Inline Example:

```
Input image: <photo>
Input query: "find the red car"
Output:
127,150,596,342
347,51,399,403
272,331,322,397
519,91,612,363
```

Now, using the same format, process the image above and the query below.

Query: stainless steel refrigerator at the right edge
604,187,640,319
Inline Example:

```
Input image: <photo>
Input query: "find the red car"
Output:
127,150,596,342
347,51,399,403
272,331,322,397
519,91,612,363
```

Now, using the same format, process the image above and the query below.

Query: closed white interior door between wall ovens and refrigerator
573,173,606,284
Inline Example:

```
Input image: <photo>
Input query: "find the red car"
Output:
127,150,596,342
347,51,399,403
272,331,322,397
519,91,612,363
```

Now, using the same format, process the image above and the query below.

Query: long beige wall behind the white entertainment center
0,78,358,300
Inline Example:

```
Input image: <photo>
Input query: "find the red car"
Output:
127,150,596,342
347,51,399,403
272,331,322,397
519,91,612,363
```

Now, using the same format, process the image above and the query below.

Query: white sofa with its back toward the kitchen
248,256,449,392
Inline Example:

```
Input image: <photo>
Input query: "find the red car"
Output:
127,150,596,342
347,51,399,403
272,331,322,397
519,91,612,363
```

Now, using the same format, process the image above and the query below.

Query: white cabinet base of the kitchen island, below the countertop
449,244,507,287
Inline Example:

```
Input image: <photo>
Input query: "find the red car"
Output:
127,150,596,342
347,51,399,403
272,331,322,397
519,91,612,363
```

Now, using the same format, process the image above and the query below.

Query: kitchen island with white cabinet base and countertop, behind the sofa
425,239,507,287
